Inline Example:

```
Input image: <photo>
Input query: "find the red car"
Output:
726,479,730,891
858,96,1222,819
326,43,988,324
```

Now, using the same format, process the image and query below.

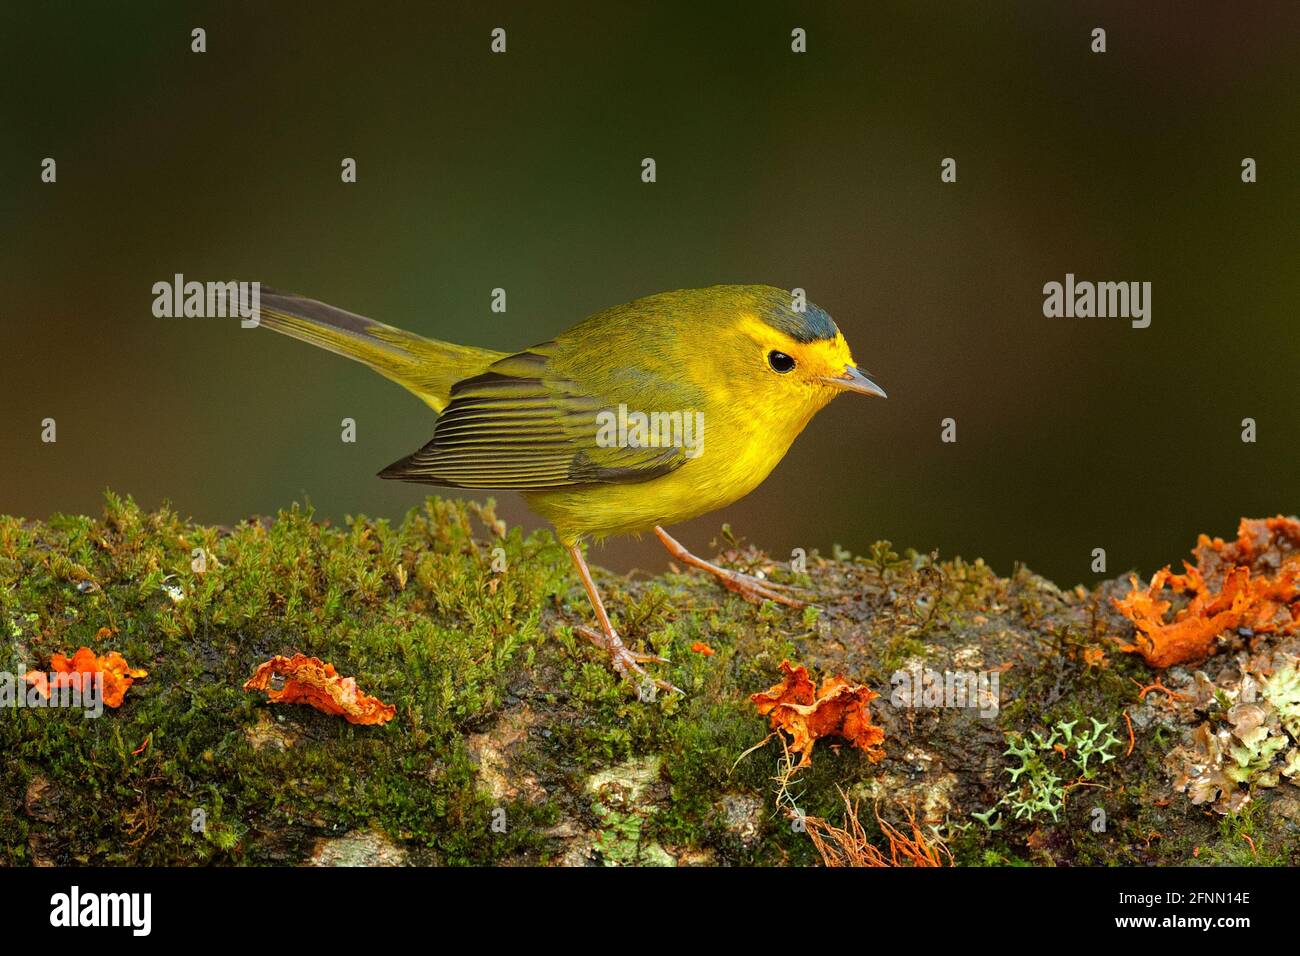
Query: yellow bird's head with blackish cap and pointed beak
702,286,885,415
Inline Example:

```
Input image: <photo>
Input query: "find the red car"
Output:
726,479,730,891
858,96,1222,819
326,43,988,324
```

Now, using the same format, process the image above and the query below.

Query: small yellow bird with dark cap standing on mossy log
260,285,885,689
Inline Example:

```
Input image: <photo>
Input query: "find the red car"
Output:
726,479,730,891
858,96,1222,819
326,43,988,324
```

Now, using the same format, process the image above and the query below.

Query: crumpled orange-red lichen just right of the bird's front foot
750,661,885,767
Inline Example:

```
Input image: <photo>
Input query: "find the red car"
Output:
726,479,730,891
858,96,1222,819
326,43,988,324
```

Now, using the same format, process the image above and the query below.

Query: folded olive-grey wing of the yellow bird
380,342,686,490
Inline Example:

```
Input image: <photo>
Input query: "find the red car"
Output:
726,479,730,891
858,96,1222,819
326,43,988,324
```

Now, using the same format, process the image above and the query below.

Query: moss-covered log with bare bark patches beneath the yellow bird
0,494,1300,865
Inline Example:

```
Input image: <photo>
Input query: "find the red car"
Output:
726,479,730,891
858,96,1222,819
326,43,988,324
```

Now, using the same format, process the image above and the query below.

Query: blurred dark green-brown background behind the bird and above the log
0,0,1300,585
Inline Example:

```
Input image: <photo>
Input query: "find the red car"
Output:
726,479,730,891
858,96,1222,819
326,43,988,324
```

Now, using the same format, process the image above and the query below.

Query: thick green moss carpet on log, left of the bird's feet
0,496,566,864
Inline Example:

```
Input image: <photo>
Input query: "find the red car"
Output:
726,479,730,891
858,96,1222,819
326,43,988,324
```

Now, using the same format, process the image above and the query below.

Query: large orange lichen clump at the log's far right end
1112,516,1300,667
